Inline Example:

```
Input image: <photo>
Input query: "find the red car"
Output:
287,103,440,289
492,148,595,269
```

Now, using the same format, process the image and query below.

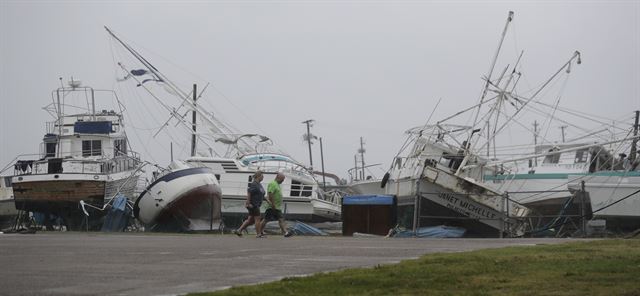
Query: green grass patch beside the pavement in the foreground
193,239,640,295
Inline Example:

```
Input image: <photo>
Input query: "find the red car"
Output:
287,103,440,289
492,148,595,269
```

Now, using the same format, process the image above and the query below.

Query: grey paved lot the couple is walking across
0,232,571,295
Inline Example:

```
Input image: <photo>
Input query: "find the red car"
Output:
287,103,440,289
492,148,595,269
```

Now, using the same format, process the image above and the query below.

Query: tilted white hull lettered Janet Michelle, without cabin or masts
385,167,529,237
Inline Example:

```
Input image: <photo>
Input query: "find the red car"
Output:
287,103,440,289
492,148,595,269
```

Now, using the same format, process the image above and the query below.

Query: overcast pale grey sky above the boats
0,0,640,177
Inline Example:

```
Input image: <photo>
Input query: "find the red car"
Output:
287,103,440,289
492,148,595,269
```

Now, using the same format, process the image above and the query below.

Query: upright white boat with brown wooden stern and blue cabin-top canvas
12,80,140,230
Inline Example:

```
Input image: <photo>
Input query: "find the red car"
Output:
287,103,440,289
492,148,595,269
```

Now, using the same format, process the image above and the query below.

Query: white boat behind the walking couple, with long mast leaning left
105,28,341,226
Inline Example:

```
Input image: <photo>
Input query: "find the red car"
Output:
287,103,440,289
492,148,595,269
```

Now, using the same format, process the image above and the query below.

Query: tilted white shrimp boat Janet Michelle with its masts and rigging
381,12,600,237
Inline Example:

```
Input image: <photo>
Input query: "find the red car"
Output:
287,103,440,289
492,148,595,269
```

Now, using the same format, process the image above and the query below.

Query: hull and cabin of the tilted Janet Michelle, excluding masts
382,125,529,237
